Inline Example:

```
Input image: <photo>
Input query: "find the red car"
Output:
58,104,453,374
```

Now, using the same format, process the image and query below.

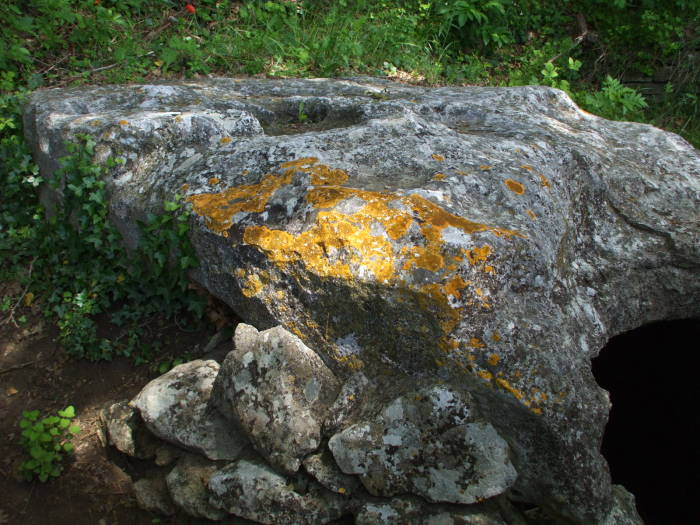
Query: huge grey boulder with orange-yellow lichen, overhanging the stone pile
25,75,700,524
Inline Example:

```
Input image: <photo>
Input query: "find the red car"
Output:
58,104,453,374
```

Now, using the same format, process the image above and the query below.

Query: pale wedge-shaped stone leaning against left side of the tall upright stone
131,360,248,460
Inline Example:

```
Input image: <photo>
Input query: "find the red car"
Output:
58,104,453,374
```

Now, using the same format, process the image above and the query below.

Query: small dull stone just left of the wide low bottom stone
165,454,228,521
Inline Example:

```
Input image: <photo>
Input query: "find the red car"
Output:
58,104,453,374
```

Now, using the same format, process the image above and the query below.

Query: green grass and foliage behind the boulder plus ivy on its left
0,0,700,360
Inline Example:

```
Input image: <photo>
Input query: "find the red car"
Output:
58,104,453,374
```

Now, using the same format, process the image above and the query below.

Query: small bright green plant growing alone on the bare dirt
19,406,80,482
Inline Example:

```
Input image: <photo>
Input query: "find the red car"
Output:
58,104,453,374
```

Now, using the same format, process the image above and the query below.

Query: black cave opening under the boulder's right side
593,319,700,525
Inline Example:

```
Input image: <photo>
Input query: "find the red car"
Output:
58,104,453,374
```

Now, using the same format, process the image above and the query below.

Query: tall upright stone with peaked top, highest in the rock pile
213,323,340,473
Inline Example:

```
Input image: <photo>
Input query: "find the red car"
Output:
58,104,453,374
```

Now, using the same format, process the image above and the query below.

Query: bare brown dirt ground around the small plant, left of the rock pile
0,283,235,525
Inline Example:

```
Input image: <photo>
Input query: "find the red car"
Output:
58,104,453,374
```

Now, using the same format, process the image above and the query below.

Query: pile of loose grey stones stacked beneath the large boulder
102,323,634,525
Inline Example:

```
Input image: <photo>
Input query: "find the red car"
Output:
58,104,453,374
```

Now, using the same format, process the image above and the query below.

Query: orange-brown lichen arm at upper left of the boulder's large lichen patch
187,173,292,233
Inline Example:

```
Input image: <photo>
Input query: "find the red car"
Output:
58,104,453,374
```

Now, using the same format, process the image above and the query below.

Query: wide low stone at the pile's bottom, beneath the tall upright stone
209,459,346,525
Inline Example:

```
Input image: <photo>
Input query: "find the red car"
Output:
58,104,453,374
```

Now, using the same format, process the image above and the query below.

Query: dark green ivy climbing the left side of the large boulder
0,96,204,362
